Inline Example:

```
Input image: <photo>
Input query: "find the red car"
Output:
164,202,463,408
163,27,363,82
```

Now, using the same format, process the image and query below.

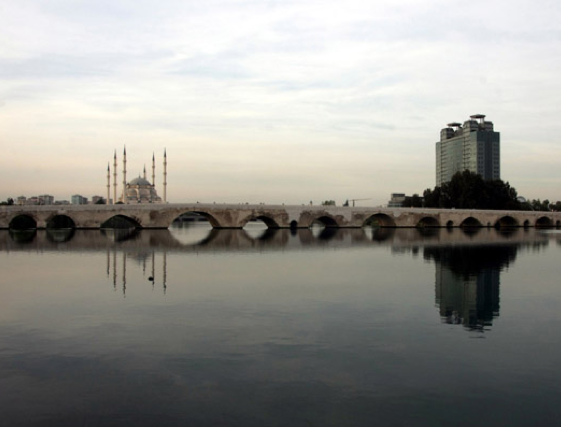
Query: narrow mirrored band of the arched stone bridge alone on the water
0,223,548,251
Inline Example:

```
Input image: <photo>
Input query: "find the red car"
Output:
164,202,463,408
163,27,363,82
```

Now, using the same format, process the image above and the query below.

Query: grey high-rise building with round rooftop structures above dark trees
436,114,501,186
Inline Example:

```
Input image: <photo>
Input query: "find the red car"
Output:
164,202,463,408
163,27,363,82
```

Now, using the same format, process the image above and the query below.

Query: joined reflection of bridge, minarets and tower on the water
0,224,561,331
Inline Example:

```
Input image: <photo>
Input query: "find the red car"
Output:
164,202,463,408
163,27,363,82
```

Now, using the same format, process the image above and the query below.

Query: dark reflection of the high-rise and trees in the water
423,245,518,331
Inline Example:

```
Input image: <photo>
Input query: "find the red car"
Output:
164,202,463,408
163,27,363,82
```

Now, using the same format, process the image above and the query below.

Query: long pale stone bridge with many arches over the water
0,203,561,229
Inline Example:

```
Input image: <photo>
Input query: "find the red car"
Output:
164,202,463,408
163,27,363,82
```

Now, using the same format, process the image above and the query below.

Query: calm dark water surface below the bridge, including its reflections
0,226,561,426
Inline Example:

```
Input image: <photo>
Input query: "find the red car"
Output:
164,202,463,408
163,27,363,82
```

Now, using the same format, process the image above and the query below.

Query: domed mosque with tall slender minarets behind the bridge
107,148,167,204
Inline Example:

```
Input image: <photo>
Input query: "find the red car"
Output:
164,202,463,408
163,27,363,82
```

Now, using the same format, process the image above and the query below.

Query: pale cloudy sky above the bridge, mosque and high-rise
0,0,561,206
